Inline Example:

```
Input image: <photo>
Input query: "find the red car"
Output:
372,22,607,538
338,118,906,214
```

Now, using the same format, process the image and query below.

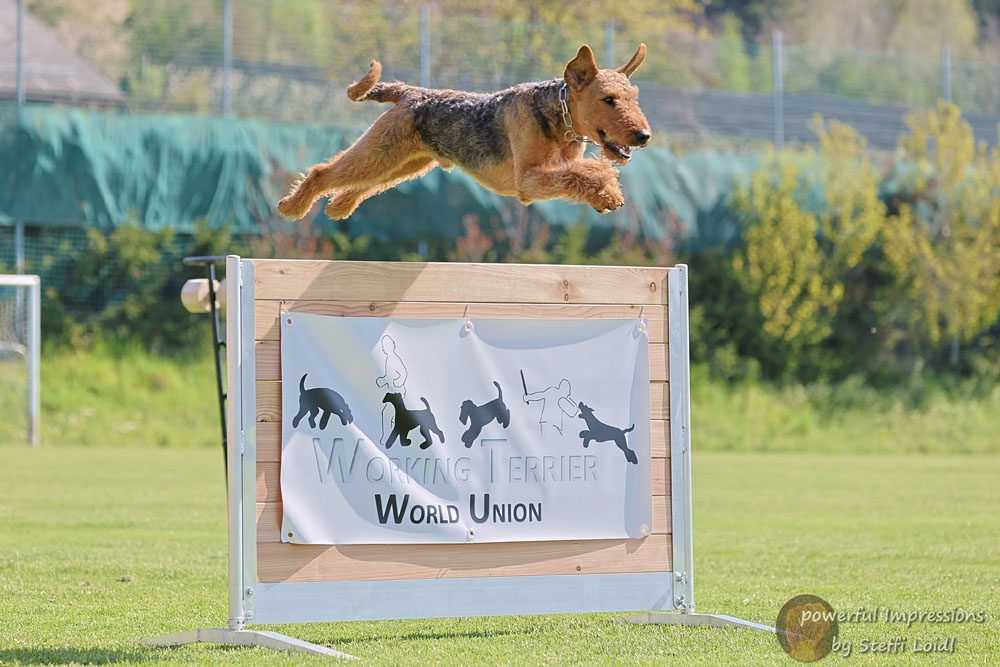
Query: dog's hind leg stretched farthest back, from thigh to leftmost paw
278,106,428,220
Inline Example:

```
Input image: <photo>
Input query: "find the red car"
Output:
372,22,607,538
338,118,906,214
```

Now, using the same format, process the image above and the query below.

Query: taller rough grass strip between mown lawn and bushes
0,346,1000,455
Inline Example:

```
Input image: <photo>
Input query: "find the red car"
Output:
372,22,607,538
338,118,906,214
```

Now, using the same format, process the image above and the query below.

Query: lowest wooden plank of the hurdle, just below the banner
257,535,673,583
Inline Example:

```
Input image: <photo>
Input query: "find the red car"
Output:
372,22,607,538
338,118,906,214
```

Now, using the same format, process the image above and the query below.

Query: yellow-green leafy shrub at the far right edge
882,102,1000,367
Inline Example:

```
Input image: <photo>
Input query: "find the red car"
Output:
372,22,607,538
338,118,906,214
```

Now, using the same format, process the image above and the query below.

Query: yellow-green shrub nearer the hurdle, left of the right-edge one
733,117,885,371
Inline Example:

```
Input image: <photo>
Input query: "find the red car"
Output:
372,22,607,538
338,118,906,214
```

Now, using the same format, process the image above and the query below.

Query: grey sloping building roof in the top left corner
0,0,125,105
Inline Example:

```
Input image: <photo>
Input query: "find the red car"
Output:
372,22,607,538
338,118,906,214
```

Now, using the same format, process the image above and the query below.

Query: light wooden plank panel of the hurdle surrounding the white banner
246,260,672,583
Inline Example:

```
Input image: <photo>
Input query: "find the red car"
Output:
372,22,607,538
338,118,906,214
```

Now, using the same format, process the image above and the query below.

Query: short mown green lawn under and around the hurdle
0,446,1000,665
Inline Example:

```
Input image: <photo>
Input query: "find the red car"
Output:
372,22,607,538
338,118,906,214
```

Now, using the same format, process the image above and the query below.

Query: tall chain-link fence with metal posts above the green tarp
11,0,1000,148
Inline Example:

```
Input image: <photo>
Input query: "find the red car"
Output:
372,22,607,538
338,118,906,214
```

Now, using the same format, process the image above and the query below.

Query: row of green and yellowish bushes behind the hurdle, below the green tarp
11,103,1000,394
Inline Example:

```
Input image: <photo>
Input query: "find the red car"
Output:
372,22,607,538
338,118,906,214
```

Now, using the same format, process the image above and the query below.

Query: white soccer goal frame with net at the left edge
0,275,41,445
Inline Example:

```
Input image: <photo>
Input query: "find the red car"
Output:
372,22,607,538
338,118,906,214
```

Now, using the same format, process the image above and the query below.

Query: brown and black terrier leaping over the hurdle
278,44,652,219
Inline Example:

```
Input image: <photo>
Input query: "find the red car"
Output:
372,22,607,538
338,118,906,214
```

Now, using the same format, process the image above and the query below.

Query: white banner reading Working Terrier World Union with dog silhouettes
281,313,652,544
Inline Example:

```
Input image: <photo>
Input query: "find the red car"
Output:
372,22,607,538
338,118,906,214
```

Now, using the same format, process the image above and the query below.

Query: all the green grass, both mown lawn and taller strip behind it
0,349,1000,665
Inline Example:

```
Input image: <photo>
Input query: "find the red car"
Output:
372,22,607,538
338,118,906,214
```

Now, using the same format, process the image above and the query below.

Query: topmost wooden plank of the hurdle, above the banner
252,259,669,305
